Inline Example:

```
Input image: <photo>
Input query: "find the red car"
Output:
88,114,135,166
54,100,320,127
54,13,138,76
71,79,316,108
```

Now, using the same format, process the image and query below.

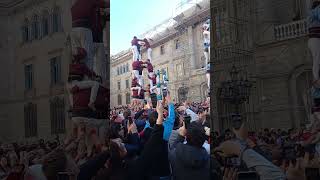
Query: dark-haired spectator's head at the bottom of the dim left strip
42,150,67,180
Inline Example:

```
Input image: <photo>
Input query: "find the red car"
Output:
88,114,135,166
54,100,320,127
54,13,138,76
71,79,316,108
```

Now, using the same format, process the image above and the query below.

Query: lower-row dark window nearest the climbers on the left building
50,97,66,134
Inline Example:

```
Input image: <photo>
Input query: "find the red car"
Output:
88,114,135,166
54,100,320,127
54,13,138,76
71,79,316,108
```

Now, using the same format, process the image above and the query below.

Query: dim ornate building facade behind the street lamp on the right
211,0,312,130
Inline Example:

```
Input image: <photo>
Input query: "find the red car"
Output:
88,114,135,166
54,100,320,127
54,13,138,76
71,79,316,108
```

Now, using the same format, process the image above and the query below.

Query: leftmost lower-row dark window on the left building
24,103,38,138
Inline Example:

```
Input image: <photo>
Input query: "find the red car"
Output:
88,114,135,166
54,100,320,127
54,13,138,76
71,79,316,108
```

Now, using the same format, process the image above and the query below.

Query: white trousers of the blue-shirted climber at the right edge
308,38,320,80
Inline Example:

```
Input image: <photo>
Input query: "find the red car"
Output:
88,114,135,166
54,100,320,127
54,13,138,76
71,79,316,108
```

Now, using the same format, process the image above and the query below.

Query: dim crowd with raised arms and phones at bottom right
211,119,320,180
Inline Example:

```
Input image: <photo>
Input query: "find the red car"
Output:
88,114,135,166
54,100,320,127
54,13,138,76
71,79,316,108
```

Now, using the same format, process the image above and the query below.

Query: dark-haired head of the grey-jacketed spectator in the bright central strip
187,122,206,148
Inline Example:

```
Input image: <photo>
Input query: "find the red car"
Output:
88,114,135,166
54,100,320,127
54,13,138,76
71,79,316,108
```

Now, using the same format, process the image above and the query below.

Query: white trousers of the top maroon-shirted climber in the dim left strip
70,27,94,70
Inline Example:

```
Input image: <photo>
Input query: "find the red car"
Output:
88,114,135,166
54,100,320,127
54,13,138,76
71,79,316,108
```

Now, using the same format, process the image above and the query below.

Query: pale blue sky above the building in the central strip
110,0,181,55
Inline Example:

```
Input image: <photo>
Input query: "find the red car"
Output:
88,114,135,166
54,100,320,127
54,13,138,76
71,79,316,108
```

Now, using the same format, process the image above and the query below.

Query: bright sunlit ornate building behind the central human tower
110,0,210,107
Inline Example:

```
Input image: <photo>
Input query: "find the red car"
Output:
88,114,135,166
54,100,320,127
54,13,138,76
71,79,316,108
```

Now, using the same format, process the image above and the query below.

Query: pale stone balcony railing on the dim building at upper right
274,19,308,41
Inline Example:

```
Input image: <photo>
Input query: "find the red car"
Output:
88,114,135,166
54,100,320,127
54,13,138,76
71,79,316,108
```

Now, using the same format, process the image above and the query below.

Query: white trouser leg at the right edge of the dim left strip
93,43,107,82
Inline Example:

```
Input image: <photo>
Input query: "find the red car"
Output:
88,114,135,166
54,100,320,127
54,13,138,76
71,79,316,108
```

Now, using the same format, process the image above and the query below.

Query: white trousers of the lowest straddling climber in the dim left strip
69,80,99,105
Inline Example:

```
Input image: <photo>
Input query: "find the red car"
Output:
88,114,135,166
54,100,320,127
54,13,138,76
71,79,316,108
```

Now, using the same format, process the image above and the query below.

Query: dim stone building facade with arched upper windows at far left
0,0,109,141
